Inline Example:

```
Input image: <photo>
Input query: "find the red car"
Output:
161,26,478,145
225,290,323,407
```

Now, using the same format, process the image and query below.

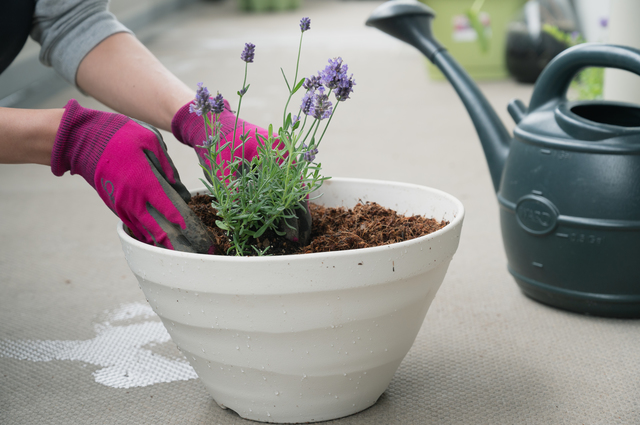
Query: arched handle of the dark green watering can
529,43,640,111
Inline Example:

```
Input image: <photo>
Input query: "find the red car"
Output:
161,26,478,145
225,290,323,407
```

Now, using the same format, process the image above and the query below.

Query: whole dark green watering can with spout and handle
367,0,640,318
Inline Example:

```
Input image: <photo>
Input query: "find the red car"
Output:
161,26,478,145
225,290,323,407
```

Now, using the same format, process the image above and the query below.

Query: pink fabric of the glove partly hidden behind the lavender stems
171,100,268,177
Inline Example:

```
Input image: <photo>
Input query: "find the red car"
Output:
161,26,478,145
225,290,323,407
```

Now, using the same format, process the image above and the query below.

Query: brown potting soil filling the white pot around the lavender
189,195,449,255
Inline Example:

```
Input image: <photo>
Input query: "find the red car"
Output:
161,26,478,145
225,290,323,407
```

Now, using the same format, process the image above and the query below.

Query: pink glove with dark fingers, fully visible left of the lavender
51,99,214,253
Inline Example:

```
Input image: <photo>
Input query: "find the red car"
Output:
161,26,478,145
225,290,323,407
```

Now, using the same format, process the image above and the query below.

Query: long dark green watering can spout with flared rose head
366,0,511,192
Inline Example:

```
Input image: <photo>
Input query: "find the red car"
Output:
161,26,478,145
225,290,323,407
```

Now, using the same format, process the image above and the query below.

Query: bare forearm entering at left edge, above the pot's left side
0,108,64,165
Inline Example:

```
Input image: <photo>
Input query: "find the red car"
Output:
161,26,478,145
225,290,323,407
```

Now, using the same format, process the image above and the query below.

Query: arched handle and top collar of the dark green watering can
510,43,640,153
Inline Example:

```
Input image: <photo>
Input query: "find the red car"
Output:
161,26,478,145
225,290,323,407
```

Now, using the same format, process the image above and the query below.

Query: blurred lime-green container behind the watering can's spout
420,0,526,80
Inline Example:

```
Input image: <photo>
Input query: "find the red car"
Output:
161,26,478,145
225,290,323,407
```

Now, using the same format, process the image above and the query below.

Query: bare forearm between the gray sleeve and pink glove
76,33,195,131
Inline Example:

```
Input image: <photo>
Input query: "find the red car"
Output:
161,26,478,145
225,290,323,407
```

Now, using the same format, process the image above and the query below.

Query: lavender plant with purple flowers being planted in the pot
190,18,355,256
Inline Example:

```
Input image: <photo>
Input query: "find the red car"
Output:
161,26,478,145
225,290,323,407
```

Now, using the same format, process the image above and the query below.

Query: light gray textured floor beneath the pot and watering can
0,0,640,424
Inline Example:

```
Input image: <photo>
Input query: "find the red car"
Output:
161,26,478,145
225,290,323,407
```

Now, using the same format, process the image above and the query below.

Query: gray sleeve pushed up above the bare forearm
31,0,131,86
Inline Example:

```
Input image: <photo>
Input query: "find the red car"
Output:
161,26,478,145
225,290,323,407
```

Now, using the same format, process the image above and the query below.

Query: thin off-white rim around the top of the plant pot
116,177,465,263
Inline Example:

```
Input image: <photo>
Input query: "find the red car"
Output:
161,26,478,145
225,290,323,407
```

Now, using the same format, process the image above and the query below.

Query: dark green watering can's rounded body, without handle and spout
497,94,640,317
